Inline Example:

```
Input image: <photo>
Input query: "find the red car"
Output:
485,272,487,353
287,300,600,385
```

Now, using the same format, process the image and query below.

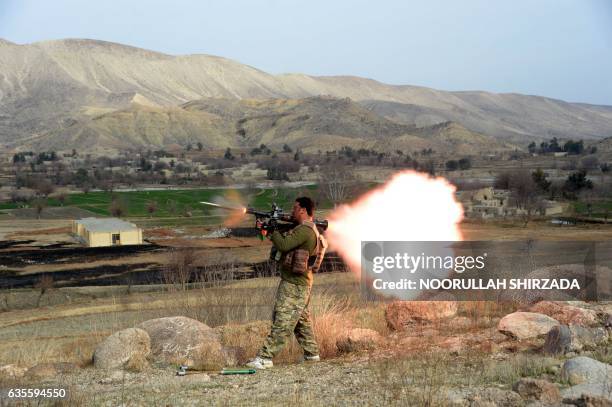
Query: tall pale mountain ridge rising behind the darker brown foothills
0,39,612,151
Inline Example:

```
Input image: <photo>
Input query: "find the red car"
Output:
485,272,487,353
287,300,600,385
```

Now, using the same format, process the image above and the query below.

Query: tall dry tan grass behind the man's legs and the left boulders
0,275,368,366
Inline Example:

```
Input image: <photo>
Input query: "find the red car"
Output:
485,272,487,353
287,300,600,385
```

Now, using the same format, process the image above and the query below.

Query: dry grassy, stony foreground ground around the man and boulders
0,273,612,406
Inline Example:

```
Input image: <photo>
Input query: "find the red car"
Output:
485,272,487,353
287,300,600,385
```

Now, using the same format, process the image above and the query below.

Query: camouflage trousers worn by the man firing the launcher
258,280,319,359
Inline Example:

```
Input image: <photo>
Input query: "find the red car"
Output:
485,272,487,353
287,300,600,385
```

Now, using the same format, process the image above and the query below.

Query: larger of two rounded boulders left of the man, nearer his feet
138,317,235,370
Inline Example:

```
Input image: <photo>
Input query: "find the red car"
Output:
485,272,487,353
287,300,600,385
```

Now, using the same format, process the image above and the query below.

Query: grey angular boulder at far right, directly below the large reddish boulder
543,325,609,355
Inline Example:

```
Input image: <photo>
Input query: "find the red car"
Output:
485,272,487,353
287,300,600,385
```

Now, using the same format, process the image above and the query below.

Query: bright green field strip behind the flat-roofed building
0,185,331,220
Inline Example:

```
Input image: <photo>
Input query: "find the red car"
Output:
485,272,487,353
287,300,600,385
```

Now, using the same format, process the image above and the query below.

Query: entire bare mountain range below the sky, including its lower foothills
0,39,612,149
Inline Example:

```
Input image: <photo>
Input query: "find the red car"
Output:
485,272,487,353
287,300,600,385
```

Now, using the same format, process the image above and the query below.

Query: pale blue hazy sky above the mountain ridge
0,0,612,105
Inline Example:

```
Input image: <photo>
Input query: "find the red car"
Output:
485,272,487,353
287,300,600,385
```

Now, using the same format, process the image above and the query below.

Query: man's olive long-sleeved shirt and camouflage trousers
258,225,319,359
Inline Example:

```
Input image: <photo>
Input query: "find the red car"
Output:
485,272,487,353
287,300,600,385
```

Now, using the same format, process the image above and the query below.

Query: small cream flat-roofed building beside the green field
72,218,142,247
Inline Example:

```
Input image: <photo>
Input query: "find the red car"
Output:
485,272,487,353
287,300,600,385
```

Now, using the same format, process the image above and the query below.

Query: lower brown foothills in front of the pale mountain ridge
33,96,507,153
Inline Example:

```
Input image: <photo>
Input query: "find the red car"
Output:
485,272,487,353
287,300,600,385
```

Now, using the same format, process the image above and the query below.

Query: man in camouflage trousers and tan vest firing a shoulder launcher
247,197,327,369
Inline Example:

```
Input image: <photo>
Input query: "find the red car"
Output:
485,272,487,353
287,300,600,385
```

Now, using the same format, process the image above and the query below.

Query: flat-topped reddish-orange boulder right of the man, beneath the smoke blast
385,301,457,331
